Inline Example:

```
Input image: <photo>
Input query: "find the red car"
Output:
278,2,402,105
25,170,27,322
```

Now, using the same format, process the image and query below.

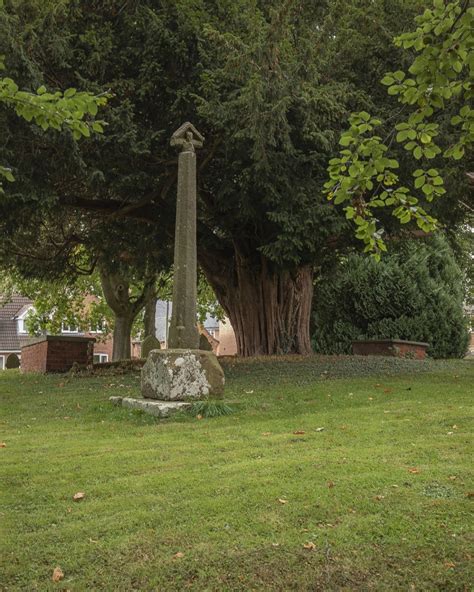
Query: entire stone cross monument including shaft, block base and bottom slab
111,123,225,417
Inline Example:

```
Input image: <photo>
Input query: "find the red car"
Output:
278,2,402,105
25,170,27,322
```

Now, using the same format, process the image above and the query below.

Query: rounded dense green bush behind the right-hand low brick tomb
313,236,468,358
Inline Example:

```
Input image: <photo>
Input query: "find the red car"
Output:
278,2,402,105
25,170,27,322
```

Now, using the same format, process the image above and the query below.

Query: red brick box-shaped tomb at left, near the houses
21,335,95,372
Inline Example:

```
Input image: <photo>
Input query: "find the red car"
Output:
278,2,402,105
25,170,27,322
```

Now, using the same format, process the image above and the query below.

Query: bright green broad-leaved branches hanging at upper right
325,0,474,259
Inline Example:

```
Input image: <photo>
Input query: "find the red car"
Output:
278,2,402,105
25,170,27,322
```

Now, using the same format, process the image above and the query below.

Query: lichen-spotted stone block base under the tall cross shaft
141,349,225,401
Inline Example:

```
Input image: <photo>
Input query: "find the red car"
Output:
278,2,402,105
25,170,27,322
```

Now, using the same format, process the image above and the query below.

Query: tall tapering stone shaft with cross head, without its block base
168,123,204,349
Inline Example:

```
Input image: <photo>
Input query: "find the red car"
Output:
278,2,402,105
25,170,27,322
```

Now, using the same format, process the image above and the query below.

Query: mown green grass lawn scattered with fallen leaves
0,357,474,592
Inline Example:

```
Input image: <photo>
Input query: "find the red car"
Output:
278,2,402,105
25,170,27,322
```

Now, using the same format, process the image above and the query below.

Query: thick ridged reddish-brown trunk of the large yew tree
200,253,313,356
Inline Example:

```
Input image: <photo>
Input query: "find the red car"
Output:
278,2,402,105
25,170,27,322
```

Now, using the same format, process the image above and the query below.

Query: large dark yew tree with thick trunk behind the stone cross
0,0,436,355
